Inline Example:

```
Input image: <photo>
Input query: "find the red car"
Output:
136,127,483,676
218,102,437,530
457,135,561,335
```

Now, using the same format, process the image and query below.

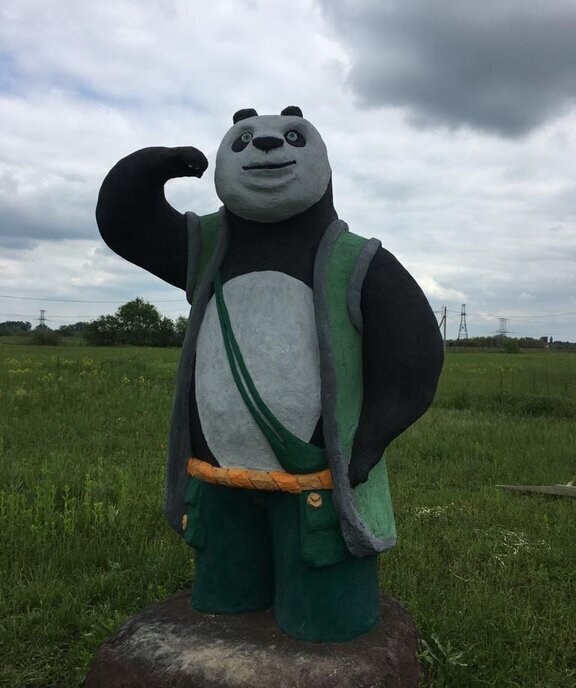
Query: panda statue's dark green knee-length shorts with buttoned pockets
184,478,378,642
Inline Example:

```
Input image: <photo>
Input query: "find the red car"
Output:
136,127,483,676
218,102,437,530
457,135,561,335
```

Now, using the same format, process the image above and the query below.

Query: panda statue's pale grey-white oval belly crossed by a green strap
195,271,321,471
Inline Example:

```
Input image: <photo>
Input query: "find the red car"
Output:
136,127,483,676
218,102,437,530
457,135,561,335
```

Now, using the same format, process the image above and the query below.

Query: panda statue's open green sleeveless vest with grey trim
164,209,396,557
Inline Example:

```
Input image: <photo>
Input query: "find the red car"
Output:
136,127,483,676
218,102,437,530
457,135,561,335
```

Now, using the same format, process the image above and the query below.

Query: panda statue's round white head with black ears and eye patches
215,107,331,222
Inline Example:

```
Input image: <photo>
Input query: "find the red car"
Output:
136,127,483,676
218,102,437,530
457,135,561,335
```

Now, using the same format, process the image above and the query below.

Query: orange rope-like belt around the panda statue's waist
188,458,333,494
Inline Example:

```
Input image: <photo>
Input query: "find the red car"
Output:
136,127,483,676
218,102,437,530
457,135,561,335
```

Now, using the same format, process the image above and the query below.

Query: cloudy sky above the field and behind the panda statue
0,0,576,341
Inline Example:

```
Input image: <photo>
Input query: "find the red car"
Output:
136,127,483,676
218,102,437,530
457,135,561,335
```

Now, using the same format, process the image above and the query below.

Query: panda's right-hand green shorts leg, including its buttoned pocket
268,490,379,642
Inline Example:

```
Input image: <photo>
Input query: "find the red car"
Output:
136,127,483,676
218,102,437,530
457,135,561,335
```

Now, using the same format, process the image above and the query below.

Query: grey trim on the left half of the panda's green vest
164,208,228,535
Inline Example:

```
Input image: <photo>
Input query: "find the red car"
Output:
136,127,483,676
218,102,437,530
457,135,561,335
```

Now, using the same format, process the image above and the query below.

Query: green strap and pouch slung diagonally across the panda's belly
214,272,326,473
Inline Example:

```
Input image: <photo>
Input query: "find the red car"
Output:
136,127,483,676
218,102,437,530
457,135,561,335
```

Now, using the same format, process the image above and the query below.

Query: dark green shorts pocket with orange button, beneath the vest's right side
300,490,352,567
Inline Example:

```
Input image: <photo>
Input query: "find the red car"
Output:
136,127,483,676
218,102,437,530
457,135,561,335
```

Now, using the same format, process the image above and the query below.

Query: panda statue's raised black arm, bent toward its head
96,147,208,288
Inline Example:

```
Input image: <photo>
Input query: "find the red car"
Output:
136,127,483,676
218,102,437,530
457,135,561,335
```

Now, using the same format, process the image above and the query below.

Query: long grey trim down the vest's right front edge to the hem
314,220,395,557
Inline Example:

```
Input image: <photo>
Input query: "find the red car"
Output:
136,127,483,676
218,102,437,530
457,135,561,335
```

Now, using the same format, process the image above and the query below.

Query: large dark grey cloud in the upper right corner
320,0,576,137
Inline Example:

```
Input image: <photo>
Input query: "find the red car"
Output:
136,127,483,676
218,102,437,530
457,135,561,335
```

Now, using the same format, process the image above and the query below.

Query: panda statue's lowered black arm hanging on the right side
349,248,444,486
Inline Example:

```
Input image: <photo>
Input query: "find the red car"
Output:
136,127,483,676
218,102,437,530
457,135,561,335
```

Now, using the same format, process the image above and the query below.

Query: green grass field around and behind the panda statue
0,345,576,688
